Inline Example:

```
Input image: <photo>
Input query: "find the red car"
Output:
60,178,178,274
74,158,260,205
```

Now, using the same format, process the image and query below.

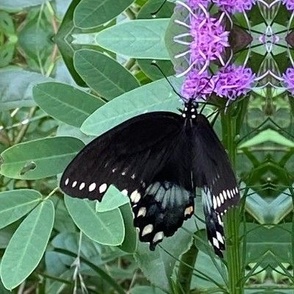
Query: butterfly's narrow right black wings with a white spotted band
193,114,240,257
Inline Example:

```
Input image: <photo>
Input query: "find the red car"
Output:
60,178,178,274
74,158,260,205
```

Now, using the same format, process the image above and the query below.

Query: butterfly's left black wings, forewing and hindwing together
60,112,195,250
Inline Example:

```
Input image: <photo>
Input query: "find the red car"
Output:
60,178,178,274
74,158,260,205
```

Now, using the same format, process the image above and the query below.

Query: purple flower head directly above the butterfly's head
181,70,214,101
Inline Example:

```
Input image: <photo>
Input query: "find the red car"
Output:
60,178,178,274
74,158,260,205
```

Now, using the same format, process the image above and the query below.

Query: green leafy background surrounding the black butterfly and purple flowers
0,0,294,293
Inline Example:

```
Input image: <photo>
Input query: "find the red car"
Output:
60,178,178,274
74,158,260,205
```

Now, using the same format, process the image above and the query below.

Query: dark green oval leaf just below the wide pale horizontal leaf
74,50,139,99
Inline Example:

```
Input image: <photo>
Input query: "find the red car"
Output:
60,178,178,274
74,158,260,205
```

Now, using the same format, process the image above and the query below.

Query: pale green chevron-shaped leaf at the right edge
238,129,294,149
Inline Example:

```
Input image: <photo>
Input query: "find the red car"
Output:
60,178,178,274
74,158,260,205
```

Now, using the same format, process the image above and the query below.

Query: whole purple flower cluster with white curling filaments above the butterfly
175,0,255,101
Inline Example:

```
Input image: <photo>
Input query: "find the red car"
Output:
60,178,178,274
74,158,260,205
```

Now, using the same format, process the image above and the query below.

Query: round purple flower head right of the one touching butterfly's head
213,65,255,100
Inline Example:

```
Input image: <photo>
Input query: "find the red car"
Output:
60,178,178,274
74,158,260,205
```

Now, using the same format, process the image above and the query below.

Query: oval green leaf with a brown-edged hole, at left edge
0,137,84,180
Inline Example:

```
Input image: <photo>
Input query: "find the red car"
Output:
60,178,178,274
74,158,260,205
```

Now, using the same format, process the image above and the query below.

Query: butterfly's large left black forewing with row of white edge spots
60,112,181,201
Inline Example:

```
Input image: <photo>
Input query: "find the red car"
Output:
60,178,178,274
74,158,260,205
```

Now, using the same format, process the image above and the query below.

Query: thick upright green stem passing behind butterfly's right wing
221,109,244,294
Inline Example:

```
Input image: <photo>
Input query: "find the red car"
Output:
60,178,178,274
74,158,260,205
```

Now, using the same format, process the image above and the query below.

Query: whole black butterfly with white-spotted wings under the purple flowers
60,100,239,257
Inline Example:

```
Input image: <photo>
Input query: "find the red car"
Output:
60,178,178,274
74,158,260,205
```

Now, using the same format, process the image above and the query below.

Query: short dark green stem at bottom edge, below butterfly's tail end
176,242,198,294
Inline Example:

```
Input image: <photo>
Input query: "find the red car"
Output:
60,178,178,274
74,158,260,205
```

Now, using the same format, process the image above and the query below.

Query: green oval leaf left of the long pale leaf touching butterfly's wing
33,82,104,128
